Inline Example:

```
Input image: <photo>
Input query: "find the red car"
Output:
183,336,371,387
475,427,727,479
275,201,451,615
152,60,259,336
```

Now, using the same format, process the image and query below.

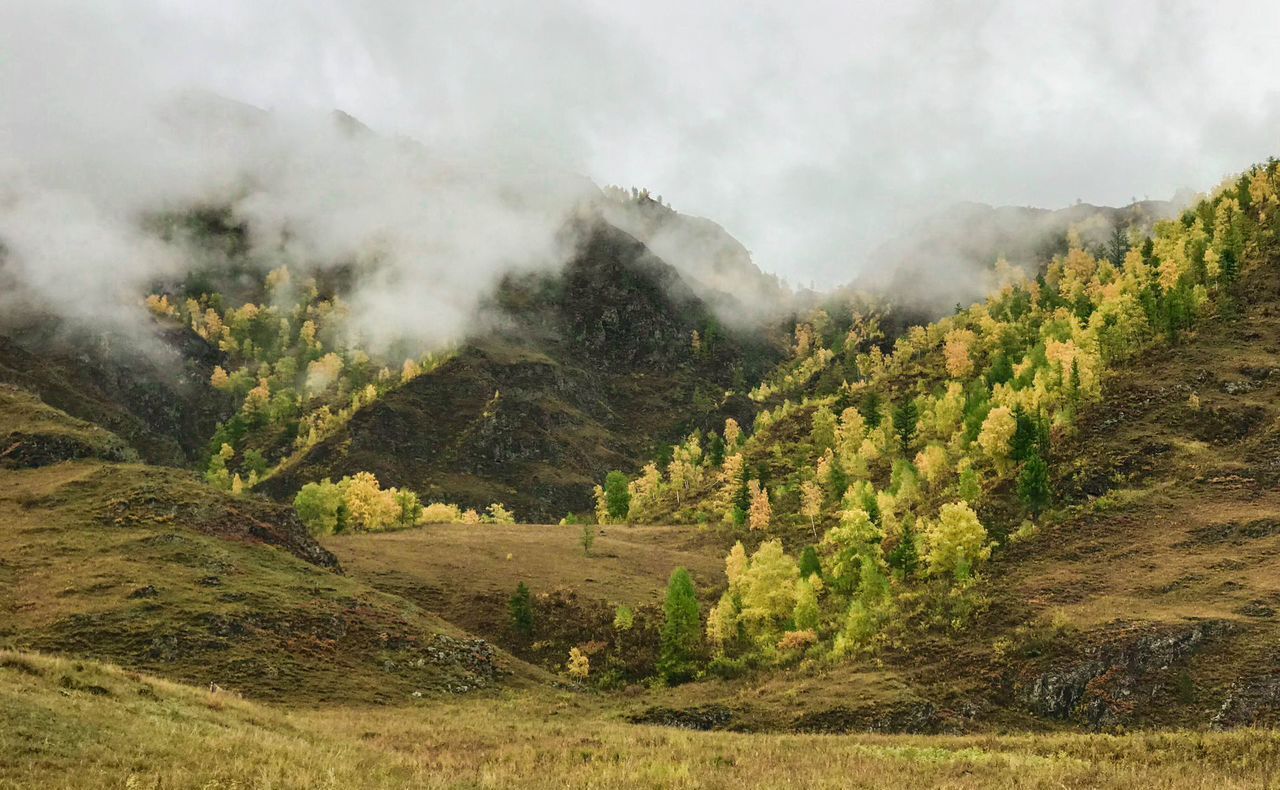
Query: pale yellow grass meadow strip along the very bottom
0,652,1280,790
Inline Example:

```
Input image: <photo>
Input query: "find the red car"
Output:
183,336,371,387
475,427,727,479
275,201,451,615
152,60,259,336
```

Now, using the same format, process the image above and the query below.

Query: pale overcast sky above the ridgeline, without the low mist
0,0,1280,284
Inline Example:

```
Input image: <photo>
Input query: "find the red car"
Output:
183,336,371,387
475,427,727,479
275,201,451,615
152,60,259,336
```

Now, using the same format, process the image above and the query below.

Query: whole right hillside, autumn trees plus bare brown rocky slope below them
570,163,1280,730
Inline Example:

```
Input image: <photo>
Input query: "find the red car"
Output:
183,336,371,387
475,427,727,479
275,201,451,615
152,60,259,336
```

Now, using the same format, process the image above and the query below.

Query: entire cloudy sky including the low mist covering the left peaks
0,0,1280,338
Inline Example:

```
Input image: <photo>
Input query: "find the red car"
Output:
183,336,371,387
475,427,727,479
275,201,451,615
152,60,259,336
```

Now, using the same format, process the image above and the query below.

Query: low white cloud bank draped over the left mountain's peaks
0,83,598,348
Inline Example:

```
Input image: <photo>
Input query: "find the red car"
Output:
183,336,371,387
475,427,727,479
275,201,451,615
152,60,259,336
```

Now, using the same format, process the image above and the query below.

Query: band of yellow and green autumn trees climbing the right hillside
596,161,1277,708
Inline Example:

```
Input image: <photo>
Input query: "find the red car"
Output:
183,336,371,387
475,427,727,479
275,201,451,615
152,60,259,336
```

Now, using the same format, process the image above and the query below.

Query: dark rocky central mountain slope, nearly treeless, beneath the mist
262,224,777,520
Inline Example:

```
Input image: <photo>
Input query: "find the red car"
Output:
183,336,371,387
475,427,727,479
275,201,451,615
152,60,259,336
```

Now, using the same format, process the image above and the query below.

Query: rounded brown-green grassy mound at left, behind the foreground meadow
0,461,527,704
